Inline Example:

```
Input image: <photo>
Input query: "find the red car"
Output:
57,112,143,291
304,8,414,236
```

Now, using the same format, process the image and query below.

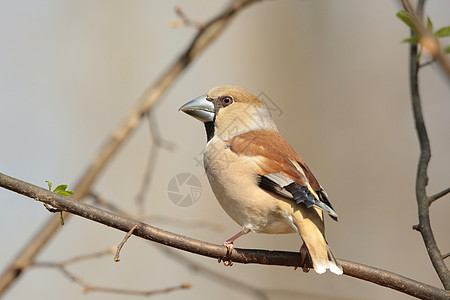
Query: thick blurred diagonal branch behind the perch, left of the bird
0,0,258,295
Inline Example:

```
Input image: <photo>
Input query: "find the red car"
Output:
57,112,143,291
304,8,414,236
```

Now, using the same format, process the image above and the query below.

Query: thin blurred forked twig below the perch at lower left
31,247,191,296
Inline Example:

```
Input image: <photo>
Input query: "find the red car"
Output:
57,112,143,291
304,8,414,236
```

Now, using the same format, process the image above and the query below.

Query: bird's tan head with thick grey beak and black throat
180,85,277,140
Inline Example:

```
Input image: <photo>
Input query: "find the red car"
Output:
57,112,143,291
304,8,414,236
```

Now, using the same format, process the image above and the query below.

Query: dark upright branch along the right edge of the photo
402,0,450,290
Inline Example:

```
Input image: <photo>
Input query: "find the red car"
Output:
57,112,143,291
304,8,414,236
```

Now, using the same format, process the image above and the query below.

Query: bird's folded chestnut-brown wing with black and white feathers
228,130,337,220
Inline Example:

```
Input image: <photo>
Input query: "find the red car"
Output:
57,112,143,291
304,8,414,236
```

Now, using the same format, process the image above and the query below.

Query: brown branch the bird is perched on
0,173,450,300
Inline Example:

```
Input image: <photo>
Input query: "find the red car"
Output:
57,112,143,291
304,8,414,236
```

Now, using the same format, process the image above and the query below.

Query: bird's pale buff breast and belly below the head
204,144,296,234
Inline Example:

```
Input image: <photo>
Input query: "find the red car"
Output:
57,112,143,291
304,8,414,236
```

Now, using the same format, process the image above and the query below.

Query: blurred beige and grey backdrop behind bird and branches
0,0,450,300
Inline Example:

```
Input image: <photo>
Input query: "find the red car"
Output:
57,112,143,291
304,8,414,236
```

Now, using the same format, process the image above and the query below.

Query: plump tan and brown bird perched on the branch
179,85,343,275
